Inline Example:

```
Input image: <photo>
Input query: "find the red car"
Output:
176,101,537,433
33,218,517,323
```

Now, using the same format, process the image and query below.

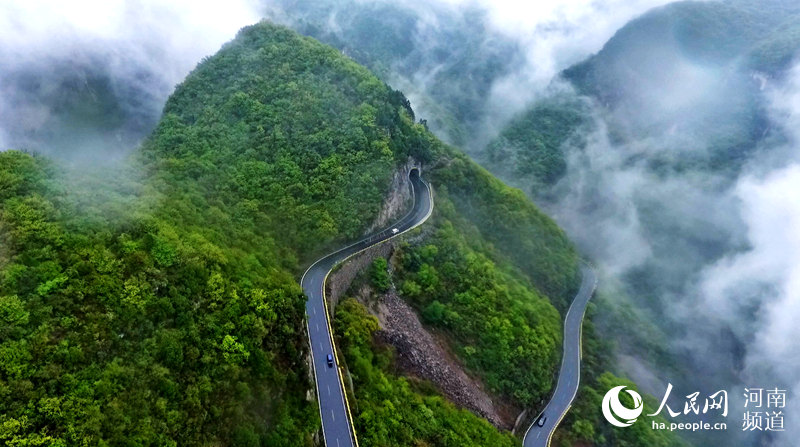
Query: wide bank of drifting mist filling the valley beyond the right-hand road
546,40,800,447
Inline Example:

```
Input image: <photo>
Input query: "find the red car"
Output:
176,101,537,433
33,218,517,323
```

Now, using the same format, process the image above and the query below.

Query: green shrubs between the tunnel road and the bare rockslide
334,299,520,447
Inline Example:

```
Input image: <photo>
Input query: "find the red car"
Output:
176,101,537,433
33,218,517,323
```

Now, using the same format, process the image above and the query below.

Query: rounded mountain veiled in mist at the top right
564,2,800,170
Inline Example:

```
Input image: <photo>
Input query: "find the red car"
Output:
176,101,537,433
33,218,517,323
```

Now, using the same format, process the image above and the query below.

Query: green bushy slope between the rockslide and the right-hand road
395,180,574,407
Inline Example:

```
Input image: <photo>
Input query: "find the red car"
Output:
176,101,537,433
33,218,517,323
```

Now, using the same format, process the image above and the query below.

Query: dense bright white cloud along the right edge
695,66,800,447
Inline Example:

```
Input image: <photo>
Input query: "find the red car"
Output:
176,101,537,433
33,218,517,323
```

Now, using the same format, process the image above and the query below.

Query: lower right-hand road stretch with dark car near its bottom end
522,266,597,447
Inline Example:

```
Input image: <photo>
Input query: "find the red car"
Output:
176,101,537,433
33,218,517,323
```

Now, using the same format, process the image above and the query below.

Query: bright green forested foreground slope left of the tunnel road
0,151,316,446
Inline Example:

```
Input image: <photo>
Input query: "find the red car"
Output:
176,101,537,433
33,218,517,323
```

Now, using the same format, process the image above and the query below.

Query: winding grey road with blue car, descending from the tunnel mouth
300,168,433,447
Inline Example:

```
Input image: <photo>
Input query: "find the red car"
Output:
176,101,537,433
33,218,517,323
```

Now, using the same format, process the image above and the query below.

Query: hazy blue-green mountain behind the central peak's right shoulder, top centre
268,0,524,147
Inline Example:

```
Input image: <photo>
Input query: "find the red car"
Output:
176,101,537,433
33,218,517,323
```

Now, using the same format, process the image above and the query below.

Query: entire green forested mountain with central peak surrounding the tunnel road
0,23,577,446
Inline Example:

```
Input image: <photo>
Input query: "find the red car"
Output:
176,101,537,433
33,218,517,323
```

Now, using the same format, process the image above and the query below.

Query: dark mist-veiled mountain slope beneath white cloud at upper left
2,55,158,159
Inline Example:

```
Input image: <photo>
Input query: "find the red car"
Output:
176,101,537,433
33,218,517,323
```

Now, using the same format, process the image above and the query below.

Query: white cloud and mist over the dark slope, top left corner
0,0,261,159
